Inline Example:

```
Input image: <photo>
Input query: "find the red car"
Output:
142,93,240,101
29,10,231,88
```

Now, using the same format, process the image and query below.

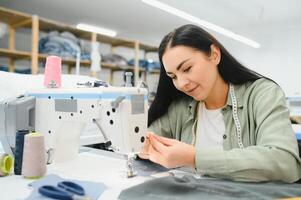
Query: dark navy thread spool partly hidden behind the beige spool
14,130,29,175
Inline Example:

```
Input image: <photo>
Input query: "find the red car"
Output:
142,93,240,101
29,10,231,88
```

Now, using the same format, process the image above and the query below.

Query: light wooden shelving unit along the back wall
0,7,159,84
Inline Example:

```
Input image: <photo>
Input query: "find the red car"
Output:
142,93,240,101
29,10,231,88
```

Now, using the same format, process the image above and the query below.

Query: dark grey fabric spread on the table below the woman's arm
119,176,301,200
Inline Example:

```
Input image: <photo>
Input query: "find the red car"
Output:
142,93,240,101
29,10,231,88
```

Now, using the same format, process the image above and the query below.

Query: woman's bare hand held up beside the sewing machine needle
148,134,195,168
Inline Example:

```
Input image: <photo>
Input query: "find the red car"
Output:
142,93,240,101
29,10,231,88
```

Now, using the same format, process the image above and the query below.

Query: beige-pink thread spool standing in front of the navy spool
22,132,46,179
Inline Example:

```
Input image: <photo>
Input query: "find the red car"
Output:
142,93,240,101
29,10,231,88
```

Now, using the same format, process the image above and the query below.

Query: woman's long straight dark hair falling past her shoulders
148,24,263,126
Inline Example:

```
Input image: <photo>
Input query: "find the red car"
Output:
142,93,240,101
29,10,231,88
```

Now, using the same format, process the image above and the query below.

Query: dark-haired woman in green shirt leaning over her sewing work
140,25,301,182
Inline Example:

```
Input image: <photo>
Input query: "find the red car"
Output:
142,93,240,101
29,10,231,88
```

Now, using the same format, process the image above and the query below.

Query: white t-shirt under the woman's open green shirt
196,102,225,150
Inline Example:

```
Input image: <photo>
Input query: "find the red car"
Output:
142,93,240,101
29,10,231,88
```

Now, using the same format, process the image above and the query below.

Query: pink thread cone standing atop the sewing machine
44,56,62,88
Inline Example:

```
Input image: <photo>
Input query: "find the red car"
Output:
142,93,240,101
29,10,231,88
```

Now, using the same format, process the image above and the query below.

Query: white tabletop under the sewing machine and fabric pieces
0,150,158,200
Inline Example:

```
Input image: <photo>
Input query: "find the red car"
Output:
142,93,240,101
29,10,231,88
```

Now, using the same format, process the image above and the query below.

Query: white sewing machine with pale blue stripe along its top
0,81,148,177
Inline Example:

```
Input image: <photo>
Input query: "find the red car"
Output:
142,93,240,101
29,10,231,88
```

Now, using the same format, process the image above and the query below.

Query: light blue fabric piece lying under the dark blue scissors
26,174,107,200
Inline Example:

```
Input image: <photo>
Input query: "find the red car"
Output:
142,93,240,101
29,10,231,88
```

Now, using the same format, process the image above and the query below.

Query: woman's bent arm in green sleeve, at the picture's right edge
196,83,301,182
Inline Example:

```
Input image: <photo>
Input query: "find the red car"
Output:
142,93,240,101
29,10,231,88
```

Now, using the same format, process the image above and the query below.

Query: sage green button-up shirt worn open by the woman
149,78,301,182
